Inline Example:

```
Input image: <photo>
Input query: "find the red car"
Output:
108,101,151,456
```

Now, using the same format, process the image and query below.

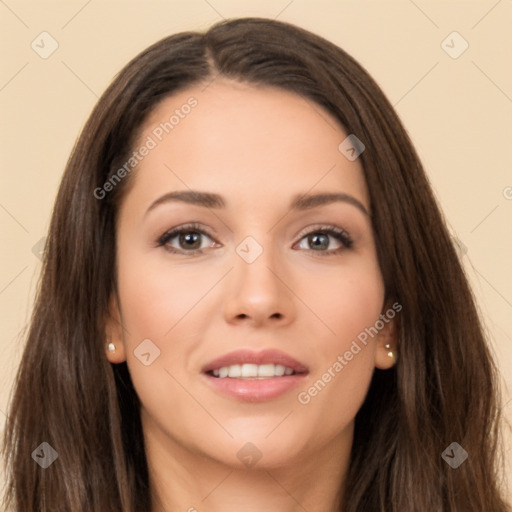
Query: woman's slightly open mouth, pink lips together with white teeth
202,350,309,402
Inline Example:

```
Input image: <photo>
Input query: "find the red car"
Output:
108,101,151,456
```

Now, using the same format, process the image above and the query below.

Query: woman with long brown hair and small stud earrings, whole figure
4,18,507,512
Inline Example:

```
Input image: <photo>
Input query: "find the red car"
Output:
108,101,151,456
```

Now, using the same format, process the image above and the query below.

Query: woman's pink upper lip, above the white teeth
201,349,309,373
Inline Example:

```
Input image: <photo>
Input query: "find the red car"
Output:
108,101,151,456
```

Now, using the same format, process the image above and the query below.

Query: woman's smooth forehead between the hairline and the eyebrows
124,79,369,214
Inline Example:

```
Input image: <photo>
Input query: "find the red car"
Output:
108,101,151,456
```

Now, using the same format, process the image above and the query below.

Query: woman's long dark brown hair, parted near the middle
3,18,509,512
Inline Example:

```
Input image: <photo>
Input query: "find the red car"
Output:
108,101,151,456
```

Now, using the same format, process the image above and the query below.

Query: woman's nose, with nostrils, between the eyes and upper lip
225,240,295,327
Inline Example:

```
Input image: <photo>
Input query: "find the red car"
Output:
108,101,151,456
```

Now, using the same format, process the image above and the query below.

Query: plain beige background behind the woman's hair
0,0,512,500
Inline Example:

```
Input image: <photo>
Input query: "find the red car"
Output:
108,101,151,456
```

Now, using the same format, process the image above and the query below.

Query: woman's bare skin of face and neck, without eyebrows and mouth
107,79,396,512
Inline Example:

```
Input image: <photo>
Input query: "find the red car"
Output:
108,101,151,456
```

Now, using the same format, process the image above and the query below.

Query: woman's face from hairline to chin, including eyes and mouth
107,79,393,467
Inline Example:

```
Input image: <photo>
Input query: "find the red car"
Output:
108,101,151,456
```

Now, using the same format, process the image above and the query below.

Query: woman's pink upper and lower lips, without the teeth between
202,350,309,402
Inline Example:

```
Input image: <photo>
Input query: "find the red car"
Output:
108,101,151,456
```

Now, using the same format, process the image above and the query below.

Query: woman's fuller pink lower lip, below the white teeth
204,374,306,402
